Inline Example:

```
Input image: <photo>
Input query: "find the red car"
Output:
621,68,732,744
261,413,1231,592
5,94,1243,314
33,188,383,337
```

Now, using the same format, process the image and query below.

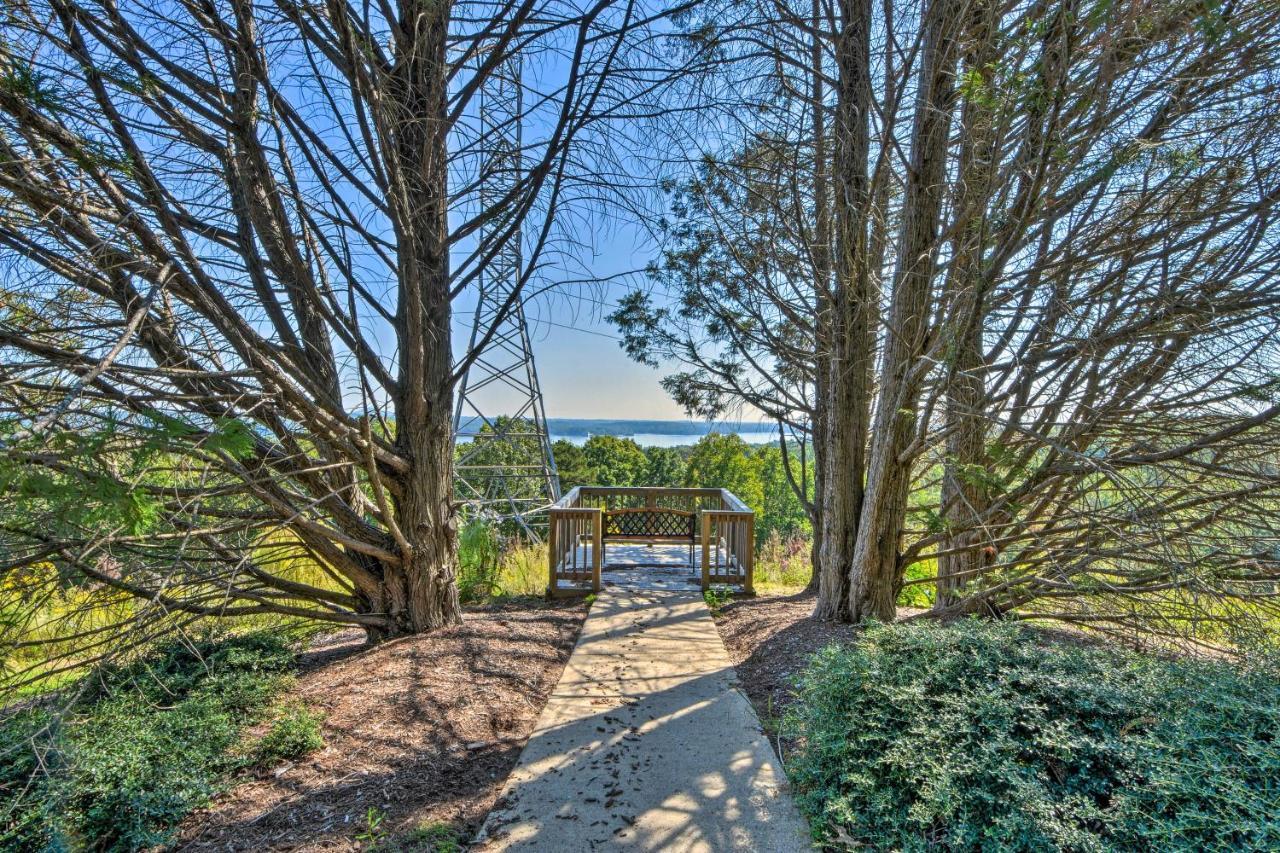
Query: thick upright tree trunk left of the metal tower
379,3,462,633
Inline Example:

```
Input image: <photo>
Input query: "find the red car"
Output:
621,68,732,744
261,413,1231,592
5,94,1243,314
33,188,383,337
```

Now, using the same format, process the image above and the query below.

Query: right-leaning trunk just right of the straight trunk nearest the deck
849,0,964,621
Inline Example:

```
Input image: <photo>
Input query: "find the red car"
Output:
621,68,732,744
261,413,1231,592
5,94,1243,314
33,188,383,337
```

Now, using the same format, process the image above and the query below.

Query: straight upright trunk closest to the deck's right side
814,0,874,621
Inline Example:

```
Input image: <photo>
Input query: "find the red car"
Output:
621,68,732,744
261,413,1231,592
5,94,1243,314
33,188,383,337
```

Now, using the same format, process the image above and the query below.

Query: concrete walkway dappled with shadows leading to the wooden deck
472,580,810,853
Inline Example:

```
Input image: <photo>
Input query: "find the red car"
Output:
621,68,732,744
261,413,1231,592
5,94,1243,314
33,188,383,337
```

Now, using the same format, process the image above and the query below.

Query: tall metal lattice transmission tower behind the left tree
453,55,559,533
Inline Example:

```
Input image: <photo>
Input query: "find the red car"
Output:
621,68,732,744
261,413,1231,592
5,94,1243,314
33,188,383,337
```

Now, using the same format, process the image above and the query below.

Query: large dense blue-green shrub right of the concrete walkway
786,621,1280,850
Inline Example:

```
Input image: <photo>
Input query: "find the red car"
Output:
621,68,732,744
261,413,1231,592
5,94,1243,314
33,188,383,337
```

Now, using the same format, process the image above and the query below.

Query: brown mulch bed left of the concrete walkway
178,603,586,850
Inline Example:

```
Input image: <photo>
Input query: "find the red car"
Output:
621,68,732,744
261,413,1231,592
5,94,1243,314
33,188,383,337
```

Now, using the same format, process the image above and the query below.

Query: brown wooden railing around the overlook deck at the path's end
548,485,755,596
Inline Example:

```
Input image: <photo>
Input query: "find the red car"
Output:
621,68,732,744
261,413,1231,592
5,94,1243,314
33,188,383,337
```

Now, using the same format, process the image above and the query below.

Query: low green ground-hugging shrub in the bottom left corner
0,633,293,850
